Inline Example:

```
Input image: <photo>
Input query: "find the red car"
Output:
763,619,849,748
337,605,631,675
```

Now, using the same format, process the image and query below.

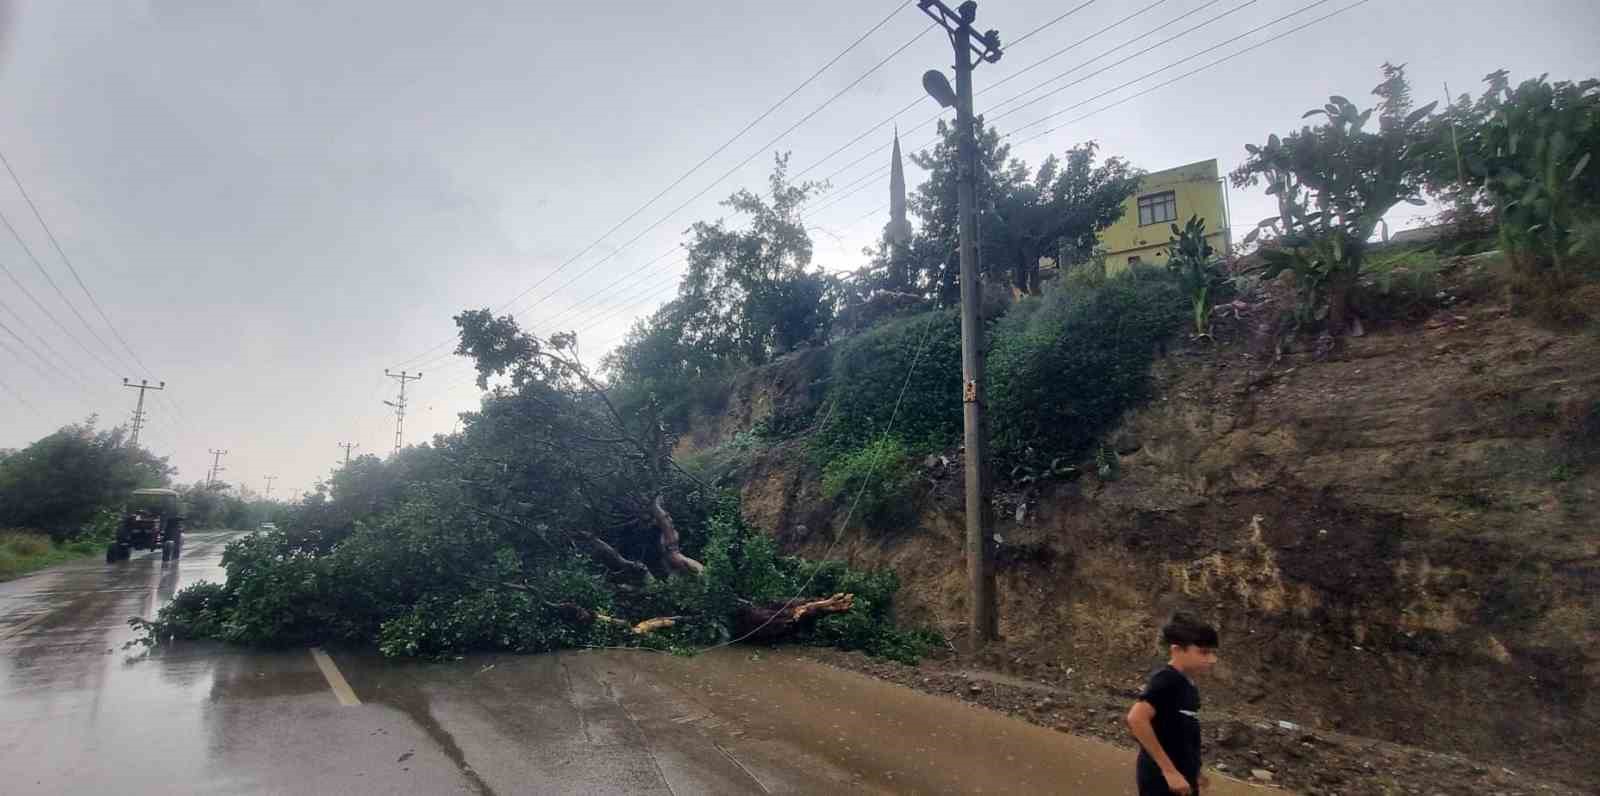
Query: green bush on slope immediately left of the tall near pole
811,310,962,462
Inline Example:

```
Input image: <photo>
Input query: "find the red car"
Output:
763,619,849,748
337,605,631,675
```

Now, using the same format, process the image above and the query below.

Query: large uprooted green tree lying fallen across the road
136,312,922,659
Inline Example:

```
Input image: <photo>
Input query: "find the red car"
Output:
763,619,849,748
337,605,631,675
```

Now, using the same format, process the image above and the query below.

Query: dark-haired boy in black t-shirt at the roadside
1128,612,1218,796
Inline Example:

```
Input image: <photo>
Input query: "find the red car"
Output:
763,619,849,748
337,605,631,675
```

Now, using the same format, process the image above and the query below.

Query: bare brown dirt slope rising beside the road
691,295,1600,793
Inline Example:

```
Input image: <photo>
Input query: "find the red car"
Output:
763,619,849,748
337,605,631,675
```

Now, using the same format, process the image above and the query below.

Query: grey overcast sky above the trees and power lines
0,0,1600,496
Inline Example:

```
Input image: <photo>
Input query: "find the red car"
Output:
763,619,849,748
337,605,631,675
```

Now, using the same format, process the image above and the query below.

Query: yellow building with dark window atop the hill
1099,158,1232,273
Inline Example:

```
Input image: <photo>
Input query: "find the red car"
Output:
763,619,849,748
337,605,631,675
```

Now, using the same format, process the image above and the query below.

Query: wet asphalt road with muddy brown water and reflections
0,532,1258,796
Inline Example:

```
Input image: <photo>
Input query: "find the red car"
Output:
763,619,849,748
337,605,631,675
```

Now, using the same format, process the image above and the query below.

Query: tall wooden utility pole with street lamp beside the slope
917,0,1000,652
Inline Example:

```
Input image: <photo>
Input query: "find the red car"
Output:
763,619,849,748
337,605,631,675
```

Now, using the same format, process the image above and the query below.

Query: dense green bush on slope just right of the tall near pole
987,267,1189,472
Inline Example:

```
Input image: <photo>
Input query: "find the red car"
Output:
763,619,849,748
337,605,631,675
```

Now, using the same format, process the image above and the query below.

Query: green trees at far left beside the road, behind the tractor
0,417,173,539
